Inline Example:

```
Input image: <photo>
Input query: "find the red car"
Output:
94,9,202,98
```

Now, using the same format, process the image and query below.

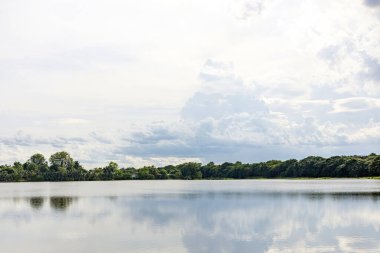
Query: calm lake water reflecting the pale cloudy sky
0,180,380,253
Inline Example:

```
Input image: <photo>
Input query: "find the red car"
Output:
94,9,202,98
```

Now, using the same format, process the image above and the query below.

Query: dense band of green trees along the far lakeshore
0,151,380,182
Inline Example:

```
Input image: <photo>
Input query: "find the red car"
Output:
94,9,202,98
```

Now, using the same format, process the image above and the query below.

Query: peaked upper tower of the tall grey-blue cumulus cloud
182,60,268,120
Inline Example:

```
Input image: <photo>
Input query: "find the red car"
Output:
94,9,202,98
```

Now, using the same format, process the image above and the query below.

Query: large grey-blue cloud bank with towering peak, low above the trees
118,57,380,162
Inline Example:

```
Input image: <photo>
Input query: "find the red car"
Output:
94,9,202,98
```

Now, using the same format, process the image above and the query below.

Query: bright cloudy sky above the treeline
0,0,380,168
